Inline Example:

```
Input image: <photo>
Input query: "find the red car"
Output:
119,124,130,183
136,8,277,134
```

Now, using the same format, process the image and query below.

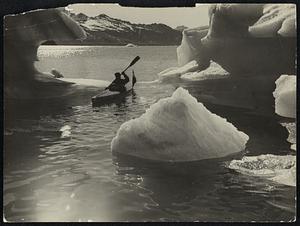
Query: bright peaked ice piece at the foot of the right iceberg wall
181,62,229,81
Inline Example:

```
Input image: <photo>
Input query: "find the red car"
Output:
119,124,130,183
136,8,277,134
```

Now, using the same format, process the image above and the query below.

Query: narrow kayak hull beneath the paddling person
92,88,133,106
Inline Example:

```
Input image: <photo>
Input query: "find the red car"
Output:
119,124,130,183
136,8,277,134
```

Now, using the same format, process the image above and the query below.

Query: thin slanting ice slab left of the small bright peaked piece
158,60,198,80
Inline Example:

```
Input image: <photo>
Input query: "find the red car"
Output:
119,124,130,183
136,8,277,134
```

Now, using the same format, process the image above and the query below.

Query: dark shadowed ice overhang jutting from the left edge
4,9,86,98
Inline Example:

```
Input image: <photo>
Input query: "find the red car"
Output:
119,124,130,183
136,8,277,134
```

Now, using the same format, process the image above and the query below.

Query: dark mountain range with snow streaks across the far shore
57,11,182,45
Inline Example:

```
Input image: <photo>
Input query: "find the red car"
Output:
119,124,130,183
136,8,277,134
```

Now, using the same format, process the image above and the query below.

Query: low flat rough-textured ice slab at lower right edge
228,154,296,186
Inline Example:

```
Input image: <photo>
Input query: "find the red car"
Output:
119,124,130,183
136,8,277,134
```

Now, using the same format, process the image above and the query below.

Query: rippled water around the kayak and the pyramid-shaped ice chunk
3,46,295,221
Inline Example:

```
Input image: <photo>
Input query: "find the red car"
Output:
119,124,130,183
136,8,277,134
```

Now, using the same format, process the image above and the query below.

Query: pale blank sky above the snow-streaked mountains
67,3,209,28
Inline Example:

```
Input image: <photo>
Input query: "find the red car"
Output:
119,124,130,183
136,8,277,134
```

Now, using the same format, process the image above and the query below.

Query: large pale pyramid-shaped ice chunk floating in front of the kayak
111,88,249,161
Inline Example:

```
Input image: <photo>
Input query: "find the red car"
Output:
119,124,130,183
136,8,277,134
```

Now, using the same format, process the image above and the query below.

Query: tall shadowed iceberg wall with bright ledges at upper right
177,3,296,74
